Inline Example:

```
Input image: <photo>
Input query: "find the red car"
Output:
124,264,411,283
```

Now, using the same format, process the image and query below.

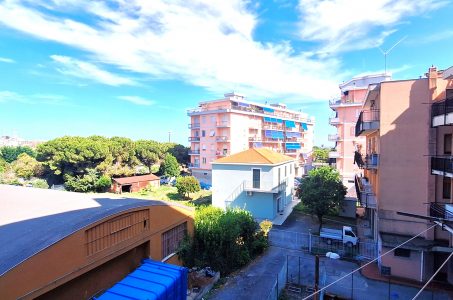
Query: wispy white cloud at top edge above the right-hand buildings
299,0,447,54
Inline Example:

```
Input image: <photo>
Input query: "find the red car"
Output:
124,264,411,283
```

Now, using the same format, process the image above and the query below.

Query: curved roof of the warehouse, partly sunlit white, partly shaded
0,184,191,276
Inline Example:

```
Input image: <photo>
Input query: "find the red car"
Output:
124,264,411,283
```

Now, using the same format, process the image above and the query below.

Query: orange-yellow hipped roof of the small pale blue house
212,148,295,165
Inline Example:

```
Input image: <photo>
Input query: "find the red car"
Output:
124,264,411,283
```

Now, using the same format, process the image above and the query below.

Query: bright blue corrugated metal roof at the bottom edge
97,259,187,300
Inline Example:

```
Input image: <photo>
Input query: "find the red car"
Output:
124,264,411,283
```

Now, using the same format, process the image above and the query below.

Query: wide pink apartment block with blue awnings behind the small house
187,93,314,184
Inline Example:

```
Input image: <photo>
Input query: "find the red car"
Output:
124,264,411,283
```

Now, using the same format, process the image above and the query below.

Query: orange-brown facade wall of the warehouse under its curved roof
0,205,194,299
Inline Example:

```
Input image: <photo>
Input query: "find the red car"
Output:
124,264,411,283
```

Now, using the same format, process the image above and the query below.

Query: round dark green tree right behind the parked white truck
296,166,346,230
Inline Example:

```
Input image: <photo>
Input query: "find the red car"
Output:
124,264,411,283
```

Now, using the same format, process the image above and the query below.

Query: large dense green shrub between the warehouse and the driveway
179,206,268,275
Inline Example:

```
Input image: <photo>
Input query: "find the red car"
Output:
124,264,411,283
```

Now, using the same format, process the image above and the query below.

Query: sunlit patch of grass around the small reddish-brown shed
109,185,212,206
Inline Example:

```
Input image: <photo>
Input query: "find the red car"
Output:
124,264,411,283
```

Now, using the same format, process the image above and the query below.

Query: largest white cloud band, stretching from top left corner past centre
0,0,341,102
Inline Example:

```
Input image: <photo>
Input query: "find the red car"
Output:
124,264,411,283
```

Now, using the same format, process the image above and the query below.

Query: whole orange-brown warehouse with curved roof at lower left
0,185,194,299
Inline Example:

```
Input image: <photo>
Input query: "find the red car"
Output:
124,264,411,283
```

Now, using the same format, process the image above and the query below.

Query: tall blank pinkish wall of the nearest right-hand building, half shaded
378,79,431,235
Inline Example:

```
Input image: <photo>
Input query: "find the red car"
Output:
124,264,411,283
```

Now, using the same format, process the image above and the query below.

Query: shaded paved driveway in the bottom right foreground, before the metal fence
210,246,453,300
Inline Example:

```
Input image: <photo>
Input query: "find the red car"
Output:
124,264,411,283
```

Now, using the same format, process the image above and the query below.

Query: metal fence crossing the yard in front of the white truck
269,229,377,261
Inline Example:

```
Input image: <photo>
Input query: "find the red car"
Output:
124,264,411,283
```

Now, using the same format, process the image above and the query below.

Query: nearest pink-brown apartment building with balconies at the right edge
355,67,453,283
